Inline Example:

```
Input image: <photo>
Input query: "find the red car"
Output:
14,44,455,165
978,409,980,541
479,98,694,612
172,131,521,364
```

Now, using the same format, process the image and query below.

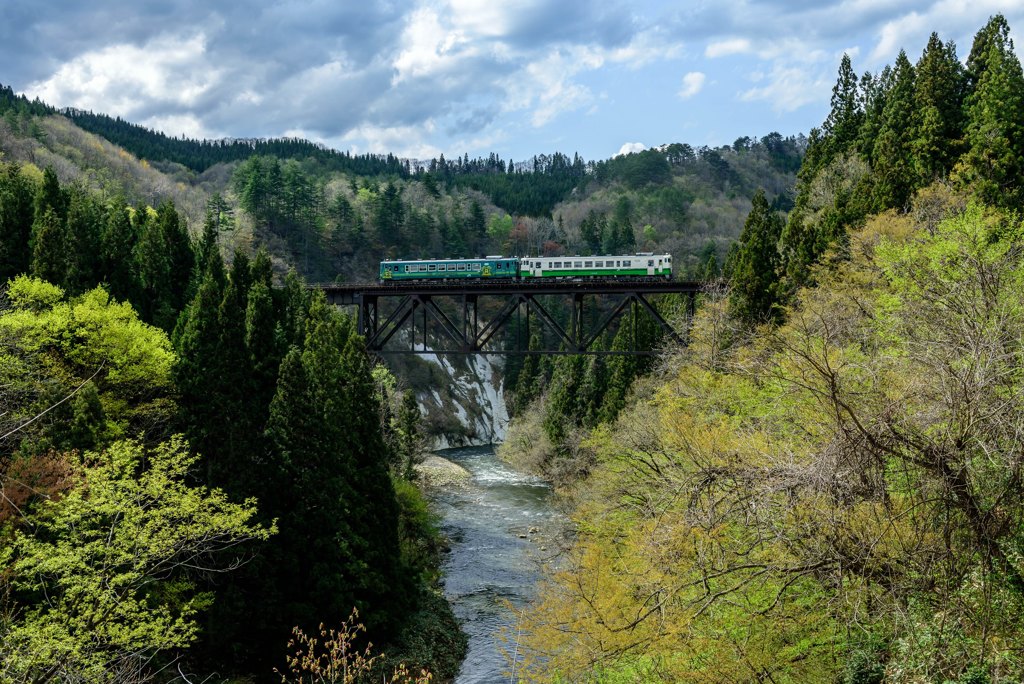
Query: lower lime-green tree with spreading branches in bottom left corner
0,439,272,682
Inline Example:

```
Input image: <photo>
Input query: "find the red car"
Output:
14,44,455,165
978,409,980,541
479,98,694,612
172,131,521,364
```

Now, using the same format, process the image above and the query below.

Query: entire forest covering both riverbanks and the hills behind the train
0,10,1024,684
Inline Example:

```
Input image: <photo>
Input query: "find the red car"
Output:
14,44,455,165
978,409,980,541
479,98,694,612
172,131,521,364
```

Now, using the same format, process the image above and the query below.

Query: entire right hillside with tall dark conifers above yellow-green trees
506,16,1024,684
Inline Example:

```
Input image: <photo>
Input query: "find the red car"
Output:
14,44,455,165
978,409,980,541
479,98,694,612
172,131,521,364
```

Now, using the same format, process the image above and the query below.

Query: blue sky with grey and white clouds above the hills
0,0,1024,161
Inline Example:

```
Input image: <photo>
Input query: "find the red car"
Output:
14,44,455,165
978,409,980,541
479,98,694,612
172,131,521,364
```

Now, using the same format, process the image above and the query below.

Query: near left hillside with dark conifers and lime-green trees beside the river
0,162,465,682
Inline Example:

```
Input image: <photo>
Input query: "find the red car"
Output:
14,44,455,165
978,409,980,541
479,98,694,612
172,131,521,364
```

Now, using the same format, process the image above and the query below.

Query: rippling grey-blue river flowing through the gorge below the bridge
432,446,565,684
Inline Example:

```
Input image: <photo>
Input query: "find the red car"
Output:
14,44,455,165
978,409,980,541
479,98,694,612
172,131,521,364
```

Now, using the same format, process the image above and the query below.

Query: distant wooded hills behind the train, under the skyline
0,77,806,281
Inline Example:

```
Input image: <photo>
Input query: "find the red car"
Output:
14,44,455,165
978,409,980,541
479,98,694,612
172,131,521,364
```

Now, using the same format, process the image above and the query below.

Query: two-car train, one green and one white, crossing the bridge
379,252,672,284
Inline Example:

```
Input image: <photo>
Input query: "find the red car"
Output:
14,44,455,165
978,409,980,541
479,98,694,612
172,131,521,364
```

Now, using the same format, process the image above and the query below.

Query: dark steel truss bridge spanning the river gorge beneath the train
314,279,707,355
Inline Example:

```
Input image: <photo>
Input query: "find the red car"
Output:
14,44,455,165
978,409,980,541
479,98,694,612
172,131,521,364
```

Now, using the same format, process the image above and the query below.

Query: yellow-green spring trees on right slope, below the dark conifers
523,202,1024,683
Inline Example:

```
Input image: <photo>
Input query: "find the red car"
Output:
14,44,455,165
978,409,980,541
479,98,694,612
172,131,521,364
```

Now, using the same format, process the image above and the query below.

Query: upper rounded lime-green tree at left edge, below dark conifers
0,275,173,454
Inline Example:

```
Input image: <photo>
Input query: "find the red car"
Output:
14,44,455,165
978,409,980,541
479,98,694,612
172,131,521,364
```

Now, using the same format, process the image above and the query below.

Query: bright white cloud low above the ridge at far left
26,34,221,117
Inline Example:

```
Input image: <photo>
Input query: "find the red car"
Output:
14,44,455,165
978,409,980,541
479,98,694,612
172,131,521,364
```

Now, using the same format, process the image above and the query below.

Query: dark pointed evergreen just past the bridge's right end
729,190,782,325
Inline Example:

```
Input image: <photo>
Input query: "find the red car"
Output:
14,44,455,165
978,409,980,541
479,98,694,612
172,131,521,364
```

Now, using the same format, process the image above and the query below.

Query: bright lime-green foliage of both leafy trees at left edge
0,275,268,681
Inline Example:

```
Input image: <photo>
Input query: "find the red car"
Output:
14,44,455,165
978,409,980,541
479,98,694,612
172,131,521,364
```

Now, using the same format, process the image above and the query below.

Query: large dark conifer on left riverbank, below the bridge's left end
256,298,406,659
